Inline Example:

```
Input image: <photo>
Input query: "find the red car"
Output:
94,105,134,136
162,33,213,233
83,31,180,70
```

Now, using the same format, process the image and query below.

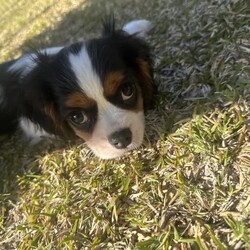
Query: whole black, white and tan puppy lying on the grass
0,20,154,159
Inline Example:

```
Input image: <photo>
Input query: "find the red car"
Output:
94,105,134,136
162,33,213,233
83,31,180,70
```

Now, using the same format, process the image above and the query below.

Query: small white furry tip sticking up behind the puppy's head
122,19,152,38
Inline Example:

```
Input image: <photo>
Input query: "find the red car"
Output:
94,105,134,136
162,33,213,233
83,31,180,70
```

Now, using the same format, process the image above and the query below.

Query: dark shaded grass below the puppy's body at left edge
0,134,74,193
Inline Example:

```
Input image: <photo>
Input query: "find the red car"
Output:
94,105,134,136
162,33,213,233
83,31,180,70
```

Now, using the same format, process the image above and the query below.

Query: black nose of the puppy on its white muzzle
108,128,132,149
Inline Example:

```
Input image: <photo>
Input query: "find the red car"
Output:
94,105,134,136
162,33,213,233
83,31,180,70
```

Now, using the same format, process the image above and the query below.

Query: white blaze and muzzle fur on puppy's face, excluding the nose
69,47,144,159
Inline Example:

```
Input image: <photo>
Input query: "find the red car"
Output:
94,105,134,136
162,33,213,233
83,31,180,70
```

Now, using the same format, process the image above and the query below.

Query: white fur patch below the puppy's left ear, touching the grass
19,117,53,143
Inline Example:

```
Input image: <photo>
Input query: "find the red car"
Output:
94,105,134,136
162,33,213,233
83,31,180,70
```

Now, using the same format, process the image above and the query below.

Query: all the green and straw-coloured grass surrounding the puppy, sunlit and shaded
0,0,250,250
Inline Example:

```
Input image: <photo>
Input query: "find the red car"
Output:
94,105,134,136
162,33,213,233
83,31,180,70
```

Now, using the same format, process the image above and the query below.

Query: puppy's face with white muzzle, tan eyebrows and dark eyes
65,60,144,159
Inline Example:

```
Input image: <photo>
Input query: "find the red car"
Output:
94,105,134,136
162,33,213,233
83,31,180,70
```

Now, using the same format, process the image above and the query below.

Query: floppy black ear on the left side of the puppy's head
20,52,72,138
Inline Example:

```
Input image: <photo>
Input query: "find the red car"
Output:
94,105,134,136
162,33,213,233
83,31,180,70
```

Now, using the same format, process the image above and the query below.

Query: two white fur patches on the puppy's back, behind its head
8,47,62,76
